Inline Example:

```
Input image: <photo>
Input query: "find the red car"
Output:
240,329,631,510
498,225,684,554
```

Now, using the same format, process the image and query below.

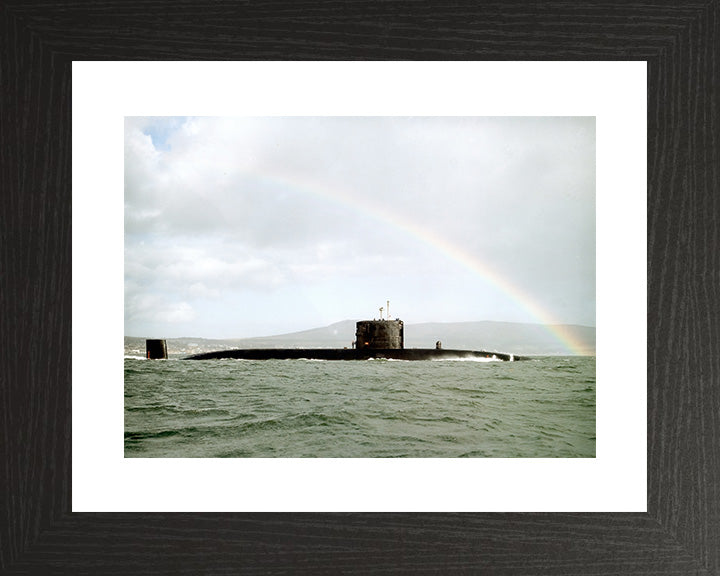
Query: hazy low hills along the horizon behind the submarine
125,320,595,356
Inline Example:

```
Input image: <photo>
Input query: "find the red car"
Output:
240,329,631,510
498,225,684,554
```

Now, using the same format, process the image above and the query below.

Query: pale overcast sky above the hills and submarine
125,117,595,342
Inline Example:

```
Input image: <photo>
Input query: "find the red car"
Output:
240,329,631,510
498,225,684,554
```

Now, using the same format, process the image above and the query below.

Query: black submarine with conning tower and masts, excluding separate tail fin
185,302,525,362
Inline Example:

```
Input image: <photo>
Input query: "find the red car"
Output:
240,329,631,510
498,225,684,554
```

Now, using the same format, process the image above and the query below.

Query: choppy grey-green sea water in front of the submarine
125,357,595,458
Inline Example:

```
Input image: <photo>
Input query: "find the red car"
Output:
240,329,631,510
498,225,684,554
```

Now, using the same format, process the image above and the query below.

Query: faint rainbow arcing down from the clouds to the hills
252,172,587,355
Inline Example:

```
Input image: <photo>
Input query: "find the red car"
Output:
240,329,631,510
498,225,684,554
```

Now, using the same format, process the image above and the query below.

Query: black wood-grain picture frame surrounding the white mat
0,0,720,576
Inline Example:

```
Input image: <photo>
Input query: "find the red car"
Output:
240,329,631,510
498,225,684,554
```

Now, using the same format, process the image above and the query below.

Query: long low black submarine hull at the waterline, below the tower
186,348,524,361
